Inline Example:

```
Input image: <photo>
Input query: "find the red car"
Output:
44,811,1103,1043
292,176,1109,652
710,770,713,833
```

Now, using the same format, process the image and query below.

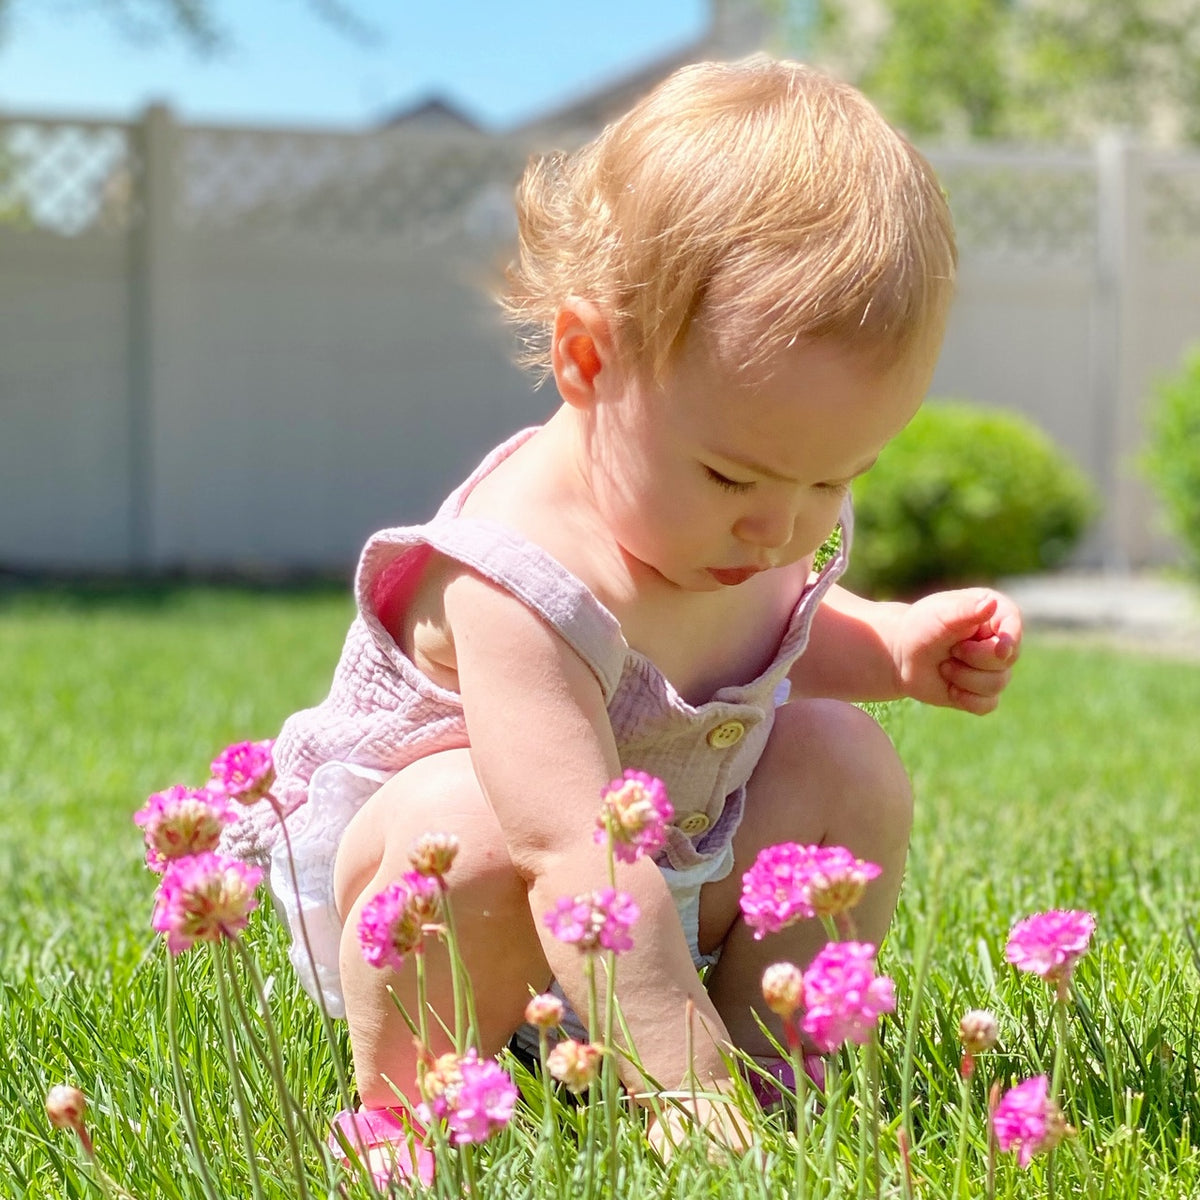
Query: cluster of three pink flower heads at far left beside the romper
133,740,275,954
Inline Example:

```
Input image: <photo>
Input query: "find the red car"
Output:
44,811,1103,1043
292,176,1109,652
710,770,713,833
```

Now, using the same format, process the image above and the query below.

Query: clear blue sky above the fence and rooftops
0,0,708,128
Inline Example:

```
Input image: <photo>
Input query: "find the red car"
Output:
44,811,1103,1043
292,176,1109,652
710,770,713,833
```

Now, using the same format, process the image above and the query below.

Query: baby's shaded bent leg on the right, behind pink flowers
700,701,912,1056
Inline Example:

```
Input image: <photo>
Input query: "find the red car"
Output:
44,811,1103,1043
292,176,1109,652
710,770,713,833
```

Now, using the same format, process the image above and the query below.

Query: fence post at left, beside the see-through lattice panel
130,104,178,570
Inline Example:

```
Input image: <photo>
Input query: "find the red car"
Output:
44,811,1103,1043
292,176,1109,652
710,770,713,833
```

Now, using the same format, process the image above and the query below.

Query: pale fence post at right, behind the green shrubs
1091,132,1146,571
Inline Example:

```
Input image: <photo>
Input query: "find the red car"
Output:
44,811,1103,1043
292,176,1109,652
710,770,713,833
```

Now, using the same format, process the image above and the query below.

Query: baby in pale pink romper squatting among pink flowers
236,58,1021,1171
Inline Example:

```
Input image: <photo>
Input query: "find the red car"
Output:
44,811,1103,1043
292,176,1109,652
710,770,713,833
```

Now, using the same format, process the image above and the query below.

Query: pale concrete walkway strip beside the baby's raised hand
1001,572,1200,658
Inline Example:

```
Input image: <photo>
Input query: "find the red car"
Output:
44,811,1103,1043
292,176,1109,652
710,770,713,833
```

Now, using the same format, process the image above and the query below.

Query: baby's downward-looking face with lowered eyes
595,337,936,590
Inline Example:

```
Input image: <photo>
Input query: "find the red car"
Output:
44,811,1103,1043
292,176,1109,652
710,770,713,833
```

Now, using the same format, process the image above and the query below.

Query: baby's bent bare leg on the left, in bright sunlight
335,750,550,1109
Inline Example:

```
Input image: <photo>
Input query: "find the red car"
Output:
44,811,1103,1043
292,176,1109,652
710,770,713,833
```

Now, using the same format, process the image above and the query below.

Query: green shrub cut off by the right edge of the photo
1144,346,1200,575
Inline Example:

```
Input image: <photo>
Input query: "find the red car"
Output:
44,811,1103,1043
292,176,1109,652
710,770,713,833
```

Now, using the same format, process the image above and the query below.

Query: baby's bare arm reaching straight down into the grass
445,571,728,1092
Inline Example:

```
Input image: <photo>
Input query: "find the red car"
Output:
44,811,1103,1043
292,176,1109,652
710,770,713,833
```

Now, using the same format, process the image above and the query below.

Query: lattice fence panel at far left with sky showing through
0,120,140,238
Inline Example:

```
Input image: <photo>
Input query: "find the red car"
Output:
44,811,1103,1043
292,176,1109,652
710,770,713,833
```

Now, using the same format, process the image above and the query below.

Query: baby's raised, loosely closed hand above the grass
893,588,1021,715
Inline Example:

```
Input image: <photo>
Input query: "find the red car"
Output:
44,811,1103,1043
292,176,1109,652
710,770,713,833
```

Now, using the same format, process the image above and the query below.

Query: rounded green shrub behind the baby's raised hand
847,400,1098,596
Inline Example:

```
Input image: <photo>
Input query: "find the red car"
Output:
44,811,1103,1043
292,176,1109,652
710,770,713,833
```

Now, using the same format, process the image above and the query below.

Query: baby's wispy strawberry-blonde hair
503,55,955,379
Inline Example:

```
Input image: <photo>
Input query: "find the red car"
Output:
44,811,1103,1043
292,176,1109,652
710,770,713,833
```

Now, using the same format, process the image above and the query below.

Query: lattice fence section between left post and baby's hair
179,130,527,244
